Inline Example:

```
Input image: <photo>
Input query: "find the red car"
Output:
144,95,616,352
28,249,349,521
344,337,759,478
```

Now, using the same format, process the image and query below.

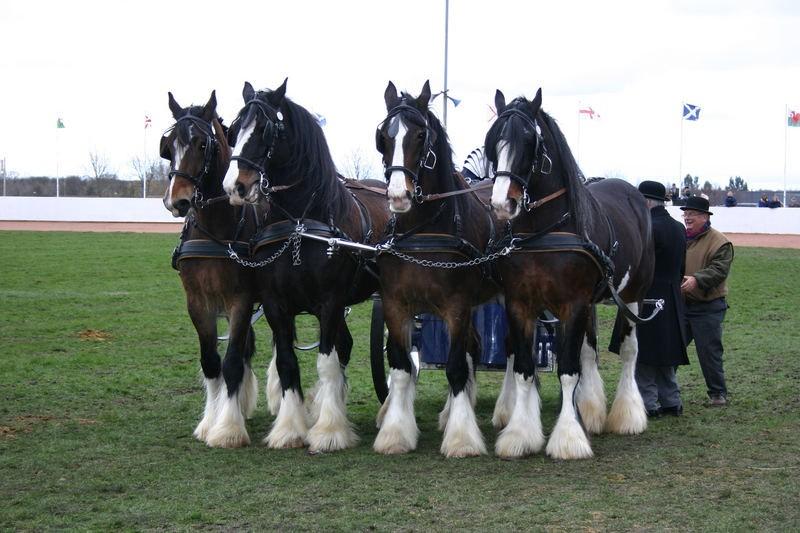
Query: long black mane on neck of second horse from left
257,91,349,222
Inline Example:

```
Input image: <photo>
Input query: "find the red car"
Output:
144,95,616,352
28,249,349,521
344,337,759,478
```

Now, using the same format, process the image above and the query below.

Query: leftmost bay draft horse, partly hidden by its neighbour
161,92,259,448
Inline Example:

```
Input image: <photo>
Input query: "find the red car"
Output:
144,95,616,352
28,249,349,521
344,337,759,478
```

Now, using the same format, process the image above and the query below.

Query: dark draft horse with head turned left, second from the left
224,80,389,452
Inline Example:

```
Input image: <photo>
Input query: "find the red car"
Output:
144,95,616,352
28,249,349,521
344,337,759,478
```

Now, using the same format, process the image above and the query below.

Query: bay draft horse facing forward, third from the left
374,82,499,457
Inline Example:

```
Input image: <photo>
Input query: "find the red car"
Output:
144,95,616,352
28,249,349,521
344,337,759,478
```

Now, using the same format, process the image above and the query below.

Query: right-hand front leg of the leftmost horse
206,304,258,448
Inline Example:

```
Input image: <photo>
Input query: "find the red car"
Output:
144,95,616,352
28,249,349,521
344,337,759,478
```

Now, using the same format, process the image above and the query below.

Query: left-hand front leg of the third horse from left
372,300,419,454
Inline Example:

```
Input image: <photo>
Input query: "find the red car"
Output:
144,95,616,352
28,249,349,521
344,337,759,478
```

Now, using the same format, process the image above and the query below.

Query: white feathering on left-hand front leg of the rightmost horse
494,374,545,459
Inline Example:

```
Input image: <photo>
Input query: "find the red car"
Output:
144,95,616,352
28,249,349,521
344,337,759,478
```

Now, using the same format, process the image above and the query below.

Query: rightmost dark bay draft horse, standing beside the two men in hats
485,89,654,459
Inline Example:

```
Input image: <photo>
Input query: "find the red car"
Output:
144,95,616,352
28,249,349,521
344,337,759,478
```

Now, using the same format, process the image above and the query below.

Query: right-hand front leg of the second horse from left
308,305,358,453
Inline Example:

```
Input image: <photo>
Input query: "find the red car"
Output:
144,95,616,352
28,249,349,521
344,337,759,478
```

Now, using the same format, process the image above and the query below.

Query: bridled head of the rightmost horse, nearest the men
485,89,553,220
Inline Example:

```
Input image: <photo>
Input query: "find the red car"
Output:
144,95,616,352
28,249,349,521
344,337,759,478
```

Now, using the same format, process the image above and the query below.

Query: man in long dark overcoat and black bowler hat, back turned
636,181,689,418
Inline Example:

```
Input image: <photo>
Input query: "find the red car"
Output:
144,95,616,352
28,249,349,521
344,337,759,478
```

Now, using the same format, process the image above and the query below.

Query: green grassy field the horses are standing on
0,232,800,531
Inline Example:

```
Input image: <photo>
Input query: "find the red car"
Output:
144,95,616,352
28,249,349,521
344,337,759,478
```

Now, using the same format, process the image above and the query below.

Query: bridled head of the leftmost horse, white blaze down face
161,91,230,217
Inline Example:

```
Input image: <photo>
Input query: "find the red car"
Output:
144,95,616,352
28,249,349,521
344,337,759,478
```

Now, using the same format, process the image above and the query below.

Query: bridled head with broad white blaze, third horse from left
375,81,452,213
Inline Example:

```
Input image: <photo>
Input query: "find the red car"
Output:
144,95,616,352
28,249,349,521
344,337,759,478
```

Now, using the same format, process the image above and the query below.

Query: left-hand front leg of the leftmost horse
189,303,223,441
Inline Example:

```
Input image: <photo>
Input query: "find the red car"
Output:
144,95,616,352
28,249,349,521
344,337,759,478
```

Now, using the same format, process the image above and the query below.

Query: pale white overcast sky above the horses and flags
0,0,800,189
